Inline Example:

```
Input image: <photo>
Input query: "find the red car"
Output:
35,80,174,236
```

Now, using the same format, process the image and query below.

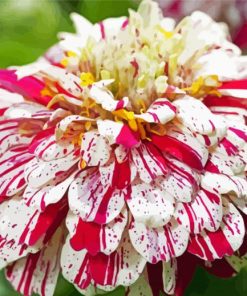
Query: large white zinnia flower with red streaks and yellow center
0,0,247,296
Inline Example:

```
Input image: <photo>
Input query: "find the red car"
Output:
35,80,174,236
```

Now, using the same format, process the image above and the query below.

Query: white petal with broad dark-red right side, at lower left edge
0,196,67,251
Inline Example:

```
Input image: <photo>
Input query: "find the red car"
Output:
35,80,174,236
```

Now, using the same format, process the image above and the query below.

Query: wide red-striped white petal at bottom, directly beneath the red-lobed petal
61,233,146,290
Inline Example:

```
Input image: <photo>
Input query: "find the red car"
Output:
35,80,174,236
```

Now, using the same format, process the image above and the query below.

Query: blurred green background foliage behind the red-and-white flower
0,0,247,296
